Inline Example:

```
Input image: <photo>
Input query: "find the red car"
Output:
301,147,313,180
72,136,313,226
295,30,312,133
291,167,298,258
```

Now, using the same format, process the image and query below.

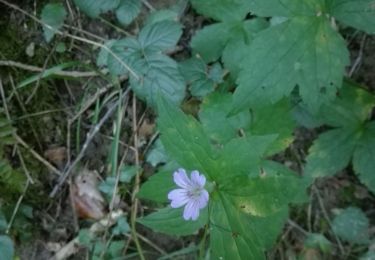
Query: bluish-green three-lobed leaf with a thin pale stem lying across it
97,21,185,107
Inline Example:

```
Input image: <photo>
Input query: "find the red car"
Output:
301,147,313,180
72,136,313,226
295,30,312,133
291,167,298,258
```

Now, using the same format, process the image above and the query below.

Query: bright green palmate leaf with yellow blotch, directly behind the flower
140,97,306,259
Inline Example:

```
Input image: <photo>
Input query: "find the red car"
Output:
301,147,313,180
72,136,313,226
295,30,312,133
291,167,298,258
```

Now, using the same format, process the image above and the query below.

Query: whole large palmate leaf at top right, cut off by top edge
233,0,375,113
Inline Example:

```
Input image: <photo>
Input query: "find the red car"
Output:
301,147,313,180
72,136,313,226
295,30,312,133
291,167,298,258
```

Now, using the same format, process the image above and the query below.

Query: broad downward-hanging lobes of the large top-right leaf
232,16,349,113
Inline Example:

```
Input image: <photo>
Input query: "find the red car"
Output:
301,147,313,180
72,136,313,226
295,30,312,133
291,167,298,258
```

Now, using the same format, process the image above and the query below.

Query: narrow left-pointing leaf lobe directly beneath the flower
138,207,208,236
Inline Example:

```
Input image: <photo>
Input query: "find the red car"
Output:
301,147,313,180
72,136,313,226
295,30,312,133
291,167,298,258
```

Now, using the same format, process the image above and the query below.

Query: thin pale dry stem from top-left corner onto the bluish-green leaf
0,0,140,80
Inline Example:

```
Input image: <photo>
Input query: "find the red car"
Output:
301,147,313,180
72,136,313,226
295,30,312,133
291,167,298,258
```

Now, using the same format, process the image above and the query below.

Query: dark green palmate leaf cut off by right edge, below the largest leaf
305,81,375,192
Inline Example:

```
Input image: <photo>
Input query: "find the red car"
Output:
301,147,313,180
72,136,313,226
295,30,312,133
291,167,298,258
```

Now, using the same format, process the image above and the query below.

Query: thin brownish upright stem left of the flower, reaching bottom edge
130,95,145,260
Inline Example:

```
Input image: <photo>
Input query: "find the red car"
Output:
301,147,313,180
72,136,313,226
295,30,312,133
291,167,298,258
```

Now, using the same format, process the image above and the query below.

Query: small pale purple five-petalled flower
168,169,209,220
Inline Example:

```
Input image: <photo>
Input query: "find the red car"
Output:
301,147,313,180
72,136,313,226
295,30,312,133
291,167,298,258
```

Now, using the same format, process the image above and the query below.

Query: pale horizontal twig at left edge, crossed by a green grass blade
0,60,99,78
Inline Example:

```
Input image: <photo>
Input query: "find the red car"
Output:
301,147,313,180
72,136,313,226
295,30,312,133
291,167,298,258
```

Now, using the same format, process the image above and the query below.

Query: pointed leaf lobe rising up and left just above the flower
158,98,216,180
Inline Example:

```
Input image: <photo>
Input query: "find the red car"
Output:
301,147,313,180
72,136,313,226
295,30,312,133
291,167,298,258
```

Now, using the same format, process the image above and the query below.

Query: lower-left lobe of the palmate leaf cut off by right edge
305,128,359,177
